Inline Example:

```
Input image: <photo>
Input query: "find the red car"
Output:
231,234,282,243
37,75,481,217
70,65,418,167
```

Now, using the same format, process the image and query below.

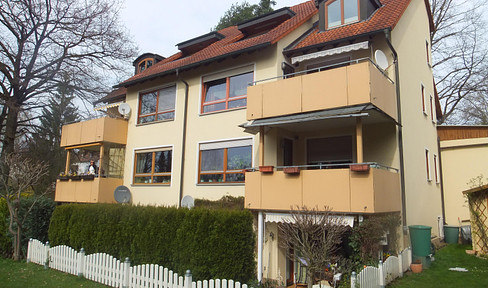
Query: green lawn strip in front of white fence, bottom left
0,258,107,288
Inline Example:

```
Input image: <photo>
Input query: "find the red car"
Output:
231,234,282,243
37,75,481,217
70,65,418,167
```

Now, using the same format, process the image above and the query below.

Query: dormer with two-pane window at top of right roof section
319,0,381,31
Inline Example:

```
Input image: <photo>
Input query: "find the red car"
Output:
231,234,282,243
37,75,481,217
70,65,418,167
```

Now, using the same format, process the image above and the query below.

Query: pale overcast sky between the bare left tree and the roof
121,0,306,57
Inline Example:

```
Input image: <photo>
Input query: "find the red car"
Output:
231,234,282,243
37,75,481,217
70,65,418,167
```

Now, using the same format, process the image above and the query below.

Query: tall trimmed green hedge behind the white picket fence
49,204,255,282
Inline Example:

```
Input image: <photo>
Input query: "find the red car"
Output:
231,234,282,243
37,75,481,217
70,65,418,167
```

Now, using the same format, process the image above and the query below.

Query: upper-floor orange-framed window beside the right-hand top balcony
202,72,254,113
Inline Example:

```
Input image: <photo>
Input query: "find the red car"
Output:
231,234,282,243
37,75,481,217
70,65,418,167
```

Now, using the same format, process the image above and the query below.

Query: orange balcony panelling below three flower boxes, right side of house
245,165,401,213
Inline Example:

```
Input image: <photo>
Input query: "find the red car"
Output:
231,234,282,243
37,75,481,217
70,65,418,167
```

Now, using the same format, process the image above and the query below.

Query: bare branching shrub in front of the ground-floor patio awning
279,207,347,288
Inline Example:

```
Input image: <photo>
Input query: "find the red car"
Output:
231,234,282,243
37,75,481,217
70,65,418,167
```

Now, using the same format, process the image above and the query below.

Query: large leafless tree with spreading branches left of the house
0,0,135,156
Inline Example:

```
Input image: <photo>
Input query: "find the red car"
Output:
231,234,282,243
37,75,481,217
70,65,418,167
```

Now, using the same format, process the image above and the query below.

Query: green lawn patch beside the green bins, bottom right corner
388,244,488,288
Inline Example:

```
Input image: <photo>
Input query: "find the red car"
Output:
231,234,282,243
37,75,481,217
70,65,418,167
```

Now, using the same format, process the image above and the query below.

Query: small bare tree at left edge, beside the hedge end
0,154,49,260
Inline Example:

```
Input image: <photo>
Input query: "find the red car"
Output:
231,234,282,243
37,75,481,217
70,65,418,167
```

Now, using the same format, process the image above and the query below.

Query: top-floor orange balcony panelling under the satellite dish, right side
247,59,397,120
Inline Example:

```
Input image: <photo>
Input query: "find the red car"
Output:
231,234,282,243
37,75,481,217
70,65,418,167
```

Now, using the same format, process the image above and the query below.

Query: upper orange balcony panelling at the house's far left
60,117,127,147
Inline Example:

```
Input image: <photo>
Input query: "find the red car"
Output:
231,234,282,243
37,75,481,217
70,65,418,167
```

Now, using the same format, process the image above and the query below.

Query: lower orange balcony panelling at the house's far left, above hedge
54,178,123,203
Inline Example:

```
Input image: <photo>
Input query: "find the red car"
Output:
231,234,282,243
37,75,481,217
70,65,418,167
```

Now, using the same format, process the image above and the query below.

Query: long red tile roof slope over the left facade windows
115,1,318,87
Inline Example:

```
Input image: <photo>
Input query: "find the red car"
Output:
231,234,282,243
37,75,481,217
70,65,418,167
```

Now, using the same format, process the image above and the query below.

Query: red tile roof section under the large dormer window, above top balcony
287,0,411,52
